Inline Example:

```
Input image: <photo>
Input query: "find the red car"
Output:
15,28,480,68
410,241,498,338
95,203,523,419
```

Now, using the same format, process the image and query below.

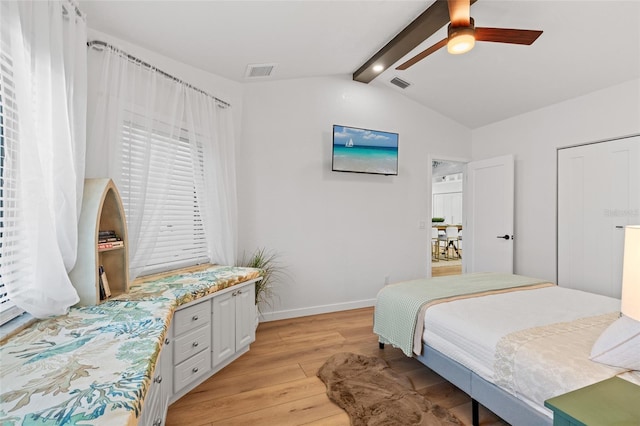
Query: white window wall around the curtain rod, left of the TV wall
85,29,243,178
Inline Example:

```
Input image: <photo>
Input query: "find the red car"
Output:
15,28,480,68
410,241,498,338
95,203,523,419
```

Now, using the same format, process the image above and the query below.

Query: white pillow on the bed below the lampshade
589,316,640,370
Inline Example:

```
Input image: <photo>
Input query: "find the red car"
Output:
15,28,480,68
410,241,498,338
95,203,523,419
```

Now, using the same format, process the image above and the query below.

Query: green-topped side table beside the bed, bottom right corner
544,377,640,426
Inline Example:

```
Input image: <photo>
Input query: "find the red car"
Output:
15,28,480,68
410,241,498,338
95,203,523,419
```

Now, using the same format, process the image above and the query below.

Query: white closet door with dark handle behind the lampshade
558,136,640,298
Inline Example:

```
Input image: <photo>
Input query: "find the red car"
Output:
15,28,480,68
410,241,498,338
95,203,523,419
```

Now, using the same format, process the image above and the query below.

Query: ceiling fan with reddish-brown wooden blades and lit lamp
396,0,542,70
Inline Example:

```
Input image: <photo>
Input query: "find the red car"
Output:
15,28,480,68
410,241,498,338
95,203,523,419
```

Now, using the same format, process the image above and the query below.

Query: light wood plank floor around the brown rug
166,308,506,426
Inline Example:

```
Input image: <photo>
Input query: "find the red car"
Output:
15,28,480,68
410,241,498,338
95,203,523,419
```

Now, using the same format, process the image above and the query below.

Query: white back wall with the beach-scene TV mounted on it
238,76,470,319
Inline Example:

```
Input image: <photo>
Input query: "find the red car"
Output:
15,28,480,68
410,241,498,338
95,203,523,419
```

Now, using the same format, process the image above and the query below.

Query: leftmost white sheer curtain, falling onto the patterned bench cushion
0,0,86,317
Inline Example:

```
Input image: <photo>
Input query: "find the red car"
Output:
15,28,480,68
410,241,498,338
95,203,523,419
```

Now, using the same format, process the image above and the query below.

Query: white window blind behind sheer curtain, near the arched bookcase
120,121,209,275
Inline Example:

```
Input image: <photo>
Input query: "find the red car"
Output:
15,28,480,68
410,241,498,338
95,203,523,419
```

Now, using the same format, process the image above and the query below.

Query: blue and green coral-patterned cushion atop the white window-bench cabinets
0,266,260,426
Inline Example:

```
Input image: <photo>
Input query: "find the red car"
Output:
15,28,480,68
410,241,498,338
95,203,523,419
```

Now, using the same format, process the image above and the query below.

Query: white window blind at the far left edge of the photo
0,26,27,325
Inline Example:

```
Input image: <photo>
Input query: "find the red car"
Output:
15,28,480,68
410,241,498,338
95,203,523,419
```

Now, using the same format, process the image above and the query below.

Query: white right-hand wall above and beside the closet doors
472,80,640,282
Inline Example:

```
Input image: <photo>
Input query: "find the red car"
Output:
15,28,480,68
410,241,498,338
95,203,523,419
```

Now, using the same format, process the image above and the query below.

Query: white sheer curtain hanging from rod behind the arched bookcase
87,46,237,279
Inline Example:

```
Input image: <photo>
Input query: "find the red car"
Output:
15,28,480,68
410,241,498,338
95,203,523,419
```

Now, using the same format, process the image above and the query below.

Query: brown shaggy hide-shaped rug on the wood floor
318,353,462,426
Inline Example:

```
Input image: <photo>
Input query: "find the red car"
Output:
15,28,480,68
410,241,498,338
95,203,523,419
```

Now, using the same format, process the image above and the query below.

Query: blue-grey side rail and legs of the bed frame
380,343,553,426
